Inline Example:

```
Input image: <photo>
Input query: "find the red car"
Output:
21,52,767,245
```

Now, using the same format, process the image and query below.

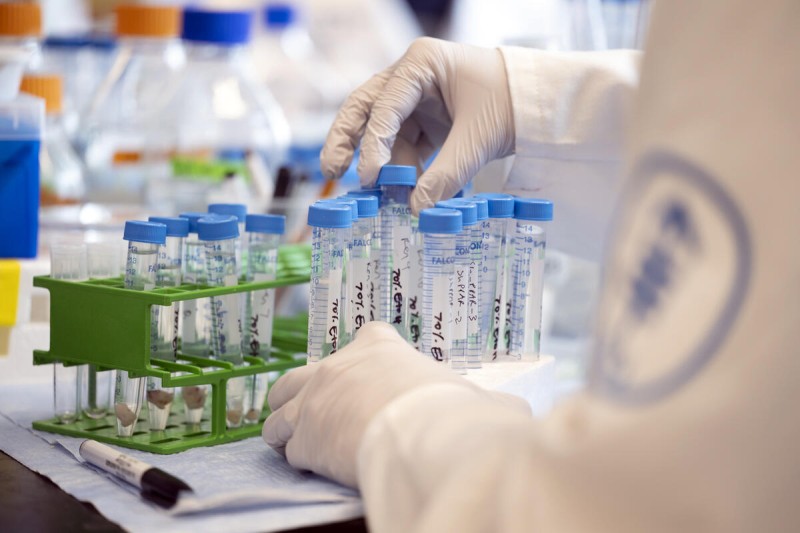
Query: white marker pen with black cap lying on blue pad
78,440,192,508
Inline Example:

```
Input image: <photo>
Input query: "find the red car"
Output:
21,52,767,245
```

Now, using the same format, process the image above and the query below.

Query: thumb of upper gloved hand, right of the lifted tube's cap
410,122,478,215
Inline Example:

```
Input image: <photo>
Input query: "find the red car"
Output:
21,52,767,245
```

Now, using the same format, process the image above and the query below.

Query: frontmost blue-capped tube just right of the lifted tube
419,207,462,363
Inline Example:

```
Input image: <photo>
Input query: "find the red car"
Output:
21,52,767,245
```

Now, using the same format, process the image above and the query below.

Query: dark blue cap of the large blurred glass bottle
181,7,253,45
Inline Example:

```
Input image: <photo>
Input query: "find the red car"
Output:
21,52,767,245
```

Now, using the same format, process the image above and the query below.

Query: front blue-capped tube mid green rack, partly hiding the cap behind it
197,216,247,428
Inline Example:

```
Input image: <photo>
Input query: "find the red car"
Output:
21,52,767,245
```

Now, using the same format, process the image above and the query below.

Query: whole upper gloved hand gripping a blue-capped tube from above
321,37,515,213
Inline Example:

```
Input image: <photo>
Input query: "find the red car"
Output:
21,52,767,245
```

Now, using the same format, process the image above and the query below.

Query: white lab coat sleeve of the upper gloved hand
501,47,641,260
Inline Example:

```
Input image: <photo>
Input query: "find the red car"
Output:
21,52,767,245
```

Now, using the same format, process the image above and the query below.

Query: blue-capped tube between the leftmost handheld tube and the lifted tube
341,196,378,334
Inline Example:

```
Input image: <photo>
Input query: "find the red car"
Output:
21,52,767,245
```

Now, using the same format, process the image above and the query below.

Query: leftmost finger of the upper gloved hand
320,69,394,179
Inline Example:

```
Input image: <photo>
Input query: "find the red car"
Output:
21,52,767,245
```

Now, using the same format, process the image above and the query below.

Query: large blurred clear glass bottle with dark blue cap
164,8,290,212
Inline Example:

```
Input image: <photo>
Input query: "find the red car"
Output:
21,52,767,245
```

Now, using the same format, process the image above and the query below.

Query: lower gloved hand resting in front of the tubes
262,322,530,487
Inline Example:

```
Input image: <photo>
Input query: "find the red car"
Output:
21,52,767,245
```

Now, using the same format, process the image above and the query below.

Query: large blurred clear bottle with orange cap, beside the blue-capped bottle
77,5,186,206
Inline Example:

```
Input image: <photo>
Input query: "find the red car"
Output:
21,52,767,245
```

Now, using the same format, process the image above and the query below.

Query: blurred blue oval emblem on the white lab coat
590,153,752,403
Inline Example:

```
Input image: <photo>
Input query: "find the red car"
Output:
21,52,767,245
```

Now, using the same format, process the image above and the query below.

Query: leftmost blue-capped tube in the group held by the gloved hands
308,202,353,363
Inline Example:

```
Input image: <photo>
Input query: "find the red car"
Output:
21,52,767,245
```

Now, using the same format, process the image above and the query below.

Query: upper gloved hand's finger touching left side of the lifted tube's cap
358,60,431,185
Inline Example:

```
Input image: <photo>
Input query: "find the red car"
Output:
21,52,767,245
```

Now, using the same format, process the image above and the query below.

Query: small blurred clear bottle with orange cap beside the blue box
20,74,86,208
